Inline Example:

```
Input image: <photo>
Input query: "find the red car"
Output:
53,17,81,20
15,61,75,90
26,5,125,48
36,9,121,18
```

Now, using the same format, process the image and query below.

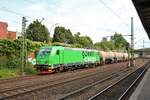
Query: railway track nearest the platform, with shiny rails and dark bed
89,62,150,100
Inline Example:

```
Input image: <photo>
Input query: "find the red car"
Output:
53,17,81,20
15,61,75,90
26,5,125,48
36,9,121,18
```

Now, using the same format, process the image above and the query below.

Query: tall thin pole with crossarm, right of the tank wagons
130,17,134,67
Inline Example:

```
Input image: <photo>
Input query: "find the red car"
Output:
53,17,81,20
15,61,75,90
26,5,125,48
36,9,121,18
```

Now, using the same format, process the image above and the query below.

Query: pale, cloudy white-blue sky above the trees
0,0,150,49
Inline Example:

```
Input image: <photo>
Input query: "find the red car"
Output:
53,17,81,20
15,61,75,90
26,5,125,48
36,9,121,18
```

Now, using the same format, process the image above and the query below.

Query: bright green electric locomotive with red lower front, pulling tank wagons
35,46,100,73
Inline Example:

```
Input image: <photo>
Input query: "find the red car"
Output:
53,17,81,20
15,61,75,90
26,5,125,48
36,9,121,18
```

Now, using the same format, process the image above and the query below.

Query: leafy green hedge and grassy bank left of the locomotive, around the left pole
0,38,50,77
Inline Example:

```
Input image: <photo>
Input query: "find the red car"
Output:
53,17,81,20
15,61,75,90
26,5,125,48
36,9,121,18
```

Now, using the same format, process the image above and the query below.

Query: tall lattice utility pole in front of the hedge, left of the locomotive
21,17,27,75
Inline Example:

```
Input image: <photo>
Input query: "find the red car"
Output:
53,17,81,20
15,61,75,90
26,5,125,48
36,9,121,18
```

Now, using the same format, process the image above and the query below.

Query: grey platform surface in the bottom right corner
129,65,150,100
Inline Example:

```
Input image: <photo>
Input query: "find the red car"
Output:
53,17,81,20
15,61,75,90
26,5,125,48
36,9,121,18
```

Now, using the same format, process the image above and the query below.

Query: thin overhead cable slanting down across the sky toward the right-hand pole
99,0,130,27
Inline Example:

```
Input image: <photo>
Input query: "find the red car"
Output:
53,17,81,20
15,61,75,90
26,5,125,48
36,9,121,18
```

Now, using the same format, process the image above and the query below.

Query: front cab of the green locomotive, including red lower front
35,46,62,73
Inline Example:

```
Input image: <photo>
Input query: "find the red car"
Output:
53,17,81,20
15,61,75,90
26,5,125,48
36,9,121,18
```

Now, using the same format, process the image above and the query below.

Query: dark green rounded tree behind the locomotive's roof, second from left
52,27,74,44
